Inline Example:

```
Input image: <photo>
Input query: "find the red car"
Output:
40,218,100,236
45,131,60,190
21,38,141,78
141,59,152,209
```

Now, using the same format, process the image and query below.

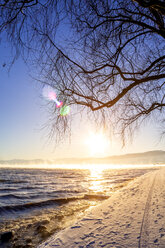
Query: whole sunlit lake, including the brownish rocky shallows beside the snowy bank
0,167,156,248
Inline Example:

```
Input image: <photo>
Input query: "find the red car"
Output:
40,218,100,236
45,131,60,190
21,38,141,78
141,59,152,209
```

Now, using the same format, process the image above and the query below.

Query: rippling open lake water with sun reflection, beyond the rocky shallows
0,168,157,218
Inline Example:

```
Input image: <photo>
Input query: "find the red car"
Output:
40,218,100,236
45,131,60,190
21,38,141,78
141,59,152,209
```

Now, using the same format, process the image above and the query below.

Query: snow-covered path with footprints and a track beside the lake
38,168,165,248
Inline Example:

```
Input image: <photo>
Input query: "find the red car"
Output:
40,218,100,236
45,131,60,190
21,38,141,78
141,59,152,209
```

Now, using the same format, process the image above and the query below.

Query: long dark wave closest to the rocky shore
0,194,109,214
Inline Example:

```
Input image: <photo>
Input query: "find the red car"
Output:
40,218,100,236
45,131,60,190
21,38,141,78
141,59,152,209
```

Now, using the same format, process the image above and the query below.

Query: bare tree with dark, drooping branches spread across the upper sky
0,0,165,143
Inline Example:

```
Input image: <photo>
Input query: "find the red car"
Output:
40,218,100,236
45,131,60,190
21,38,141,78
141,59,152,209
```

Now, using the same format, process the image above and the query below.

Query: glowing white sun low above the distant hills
85,132,109,156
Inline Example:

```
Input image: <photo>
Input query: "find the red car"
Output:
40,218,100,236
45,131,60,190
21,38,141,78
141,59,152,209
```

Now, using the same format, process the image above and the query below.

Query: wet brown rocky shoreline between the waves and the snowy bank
0,178,134,248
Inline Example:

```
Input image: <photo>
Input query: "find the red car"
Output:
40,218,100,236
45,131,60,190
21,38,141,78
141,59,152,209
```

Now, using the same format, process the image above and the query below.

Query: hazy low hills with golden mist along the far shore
0,150,165,165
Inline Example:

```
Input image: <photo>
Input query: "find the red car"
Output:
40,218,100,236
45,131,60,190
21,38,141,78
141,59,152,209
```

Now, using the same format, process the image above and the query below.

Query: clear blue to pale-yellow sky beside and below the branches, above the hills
0,40,165,159
